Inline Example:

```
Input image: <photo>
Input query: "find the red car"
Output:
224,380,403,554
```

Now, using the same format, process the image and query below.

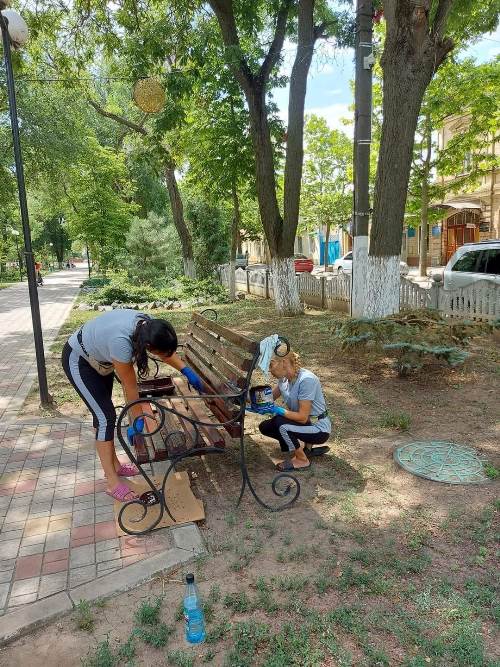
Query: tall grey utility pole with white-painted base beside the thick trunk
351,0,375,317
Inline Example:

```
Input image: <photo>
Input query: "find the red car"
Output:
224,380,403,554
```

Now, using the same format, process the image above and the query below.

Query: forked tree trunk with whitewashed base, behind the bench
209,0,318,315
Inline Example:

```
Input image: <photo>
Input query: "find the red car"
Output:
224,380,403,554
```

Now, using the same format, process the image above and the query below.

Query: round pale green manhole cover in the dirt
394,441,488,484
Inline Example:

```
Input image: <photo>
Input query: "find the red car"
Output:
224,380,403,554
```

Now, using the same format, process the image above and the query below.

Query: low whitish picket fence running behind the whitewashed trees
219,266,500,322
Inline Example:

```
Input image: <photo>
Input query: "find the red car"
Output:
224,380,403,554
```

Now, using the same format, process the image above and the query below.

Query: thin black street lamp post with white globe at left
0,0,52,407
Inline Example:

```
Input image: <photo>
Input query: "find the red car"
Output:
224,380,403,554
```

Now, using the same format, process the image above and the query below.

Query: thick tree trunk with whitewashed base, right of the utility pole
364,0,453,318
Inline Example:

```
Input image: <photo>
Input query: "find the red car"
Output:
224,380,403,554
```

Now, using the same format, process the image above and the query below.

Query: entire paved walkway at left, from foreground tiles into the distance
0,269,184,627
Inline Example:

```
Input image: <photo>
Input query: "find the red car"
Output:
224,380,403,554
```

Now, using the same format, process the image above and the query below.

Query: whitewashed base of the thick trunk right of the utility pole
363,255,401,319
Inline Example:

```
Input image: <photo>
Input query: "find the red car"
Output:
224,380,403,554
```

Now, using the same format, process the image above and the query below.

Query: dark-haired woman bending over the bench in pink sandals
62,309,203,502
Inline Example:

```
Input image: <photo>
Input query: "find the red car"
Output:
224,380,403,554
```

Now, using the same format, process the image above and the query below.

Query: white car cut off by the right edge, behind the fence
443,239,500,289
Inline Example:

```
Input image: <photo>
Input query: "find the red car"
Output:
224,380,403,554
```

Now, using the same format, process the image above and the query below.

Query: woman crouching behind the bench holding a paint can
258,351,332,472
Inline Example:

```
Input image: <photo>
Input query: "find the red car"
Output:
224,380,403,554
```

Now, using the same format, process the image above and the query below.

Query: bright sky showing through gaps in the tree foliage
273,28,500,136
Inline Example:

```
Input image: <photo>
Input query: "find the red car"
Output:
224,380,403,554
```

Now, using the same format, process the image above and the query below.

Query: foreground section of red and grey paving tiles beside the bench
0,422,172,614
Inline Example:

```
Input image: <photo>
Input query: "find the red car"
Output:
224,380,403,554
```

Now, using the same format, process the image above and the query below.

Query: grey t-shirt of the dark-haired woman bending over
69,308,147,364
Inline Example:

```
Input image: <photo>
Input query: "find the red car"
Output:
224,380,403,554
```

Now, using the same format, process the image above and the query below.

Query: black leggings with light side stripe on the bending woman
61,343,116,440
